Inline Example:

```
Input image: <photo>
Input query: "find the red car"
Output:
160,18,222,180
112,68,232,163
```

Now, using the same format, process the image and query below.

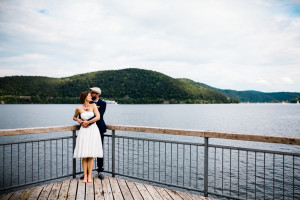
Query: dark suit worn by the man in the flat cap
96,99,106,172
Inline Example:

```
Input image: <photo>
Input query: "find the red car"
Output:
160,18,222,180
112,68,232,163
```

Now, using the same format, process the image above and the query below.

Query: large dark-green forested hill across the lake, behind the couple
0,68,237,103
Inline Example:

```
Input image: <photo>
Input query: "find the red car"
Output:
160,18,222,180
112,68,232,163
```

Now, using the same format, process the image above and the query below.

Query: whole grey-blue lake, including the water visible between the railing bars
0,104,300,197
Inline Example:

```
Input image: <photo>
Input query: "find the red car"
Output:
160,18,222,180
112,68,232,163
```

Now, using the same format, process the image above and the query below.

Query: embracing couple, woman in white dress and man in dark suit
73,87,106,183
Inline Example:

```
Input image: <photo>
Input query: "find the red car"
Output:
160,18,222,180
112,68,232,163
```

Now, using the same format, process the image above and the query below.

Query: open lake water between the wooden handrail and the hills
0,104,300,137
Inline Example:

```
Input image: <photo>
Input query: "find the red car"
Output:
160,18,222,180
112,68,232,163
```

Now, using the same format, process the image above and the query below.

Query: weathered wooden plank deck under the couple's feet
0,176,209,200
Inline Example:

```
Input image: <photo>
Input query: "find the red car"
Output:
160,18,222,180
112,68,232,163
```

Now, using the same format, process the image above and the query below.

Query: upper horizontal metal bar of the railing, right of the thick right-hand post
208,144,300,156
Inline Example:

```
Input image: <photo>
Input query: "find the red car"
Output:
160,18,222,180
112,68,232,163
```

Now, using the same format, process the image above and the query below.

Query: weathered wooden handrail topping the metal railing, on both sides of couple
0,125,300,145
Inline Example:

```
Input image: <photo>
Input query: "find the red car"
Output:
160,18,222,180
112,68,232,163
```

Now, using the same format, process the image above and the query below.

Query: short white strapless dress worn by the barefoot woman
73,112,103,158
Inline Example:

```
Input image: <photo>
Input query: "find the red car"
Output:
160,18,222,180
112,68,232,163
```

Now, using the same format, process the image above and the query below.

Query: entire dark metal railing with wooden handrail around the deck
0,125,300,199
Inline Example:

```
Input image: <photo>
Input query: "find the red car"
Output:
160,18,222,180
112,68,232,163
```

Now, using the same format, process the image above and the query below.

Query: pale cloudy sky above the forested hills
0,0,300,92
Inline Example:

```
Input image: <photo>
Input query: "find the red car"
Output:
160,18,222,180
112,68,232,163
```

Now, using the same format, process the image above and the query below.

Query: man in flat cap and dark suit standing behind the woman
80,87,106,179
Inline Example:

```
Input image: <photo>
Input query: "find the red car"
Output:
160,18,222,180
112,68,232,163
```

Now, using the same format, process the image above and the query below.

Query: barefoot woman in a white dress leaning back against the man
73,91,103,183
